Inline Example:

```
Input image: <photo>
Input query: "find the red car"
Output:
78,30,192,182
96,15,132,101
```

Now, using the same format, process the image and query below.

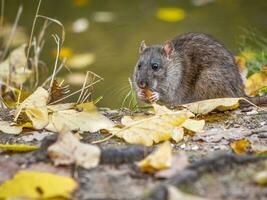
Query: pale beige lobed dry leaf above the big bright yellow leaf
48,132,101,169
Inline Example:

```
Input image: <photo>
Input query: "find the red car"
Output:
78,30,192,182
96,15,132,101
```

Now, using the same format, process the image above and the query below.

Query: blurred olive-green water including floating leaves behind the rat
4,0,267,107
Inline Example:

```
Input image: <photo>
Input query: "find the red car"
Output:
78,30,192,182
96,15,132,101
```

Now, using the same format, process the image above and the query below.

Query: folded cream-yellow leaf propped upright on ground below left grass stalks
16,87,49,130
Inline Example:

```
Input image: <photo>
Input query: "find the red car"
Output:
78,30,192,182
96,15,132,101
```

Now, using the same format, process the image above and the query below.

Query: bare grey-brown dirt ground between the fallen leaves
0,107,267,200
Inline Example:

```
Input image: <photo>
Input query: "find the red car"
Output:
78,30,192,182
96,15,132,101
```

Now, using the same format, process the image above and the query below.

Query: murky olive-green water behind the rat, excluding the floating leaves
5,0,267,107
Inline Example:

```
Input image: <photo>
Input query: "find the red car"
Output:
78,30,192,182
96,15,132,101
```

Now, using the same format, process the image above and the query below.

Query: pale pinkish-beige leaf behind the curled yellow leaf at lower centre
155,152,189,178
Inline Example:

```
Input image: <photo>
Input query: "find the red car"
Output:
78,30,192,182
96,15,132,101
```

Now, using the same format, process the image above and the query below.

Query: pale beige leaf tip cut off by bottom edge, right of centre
168,186,208,200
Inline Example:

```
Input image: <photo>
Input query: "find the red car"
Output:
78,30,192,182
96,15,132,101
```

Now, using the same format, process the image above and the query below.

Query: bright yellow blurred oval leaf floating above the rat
157,7,186,22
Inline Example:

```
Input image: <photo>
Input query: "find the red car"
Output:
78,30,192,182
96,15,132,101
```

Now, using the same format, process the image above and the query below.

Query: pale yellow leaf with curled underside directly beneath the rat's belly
183,98,241,115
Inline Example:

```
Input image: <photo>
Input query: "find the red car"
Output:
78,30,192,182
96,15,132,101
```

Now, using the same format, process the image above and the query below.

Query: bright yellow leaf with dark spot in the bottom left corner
0,171,77,199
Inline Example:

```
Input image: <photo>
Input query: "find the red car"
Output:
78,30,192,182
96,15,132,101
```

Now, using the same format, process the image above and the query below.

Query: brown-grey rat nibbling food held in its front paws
133,33,267,106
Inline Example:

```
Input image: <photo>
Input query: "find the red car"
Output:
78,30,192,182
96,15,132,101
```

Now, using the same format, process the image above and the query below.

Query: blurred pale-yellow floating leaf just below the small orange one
67,53,95,69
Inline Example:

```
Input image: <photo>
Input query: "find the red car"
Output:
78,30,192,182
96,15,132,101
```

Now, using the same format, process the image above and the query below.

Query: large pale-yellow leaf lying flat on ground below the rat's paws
111,110,192,146
